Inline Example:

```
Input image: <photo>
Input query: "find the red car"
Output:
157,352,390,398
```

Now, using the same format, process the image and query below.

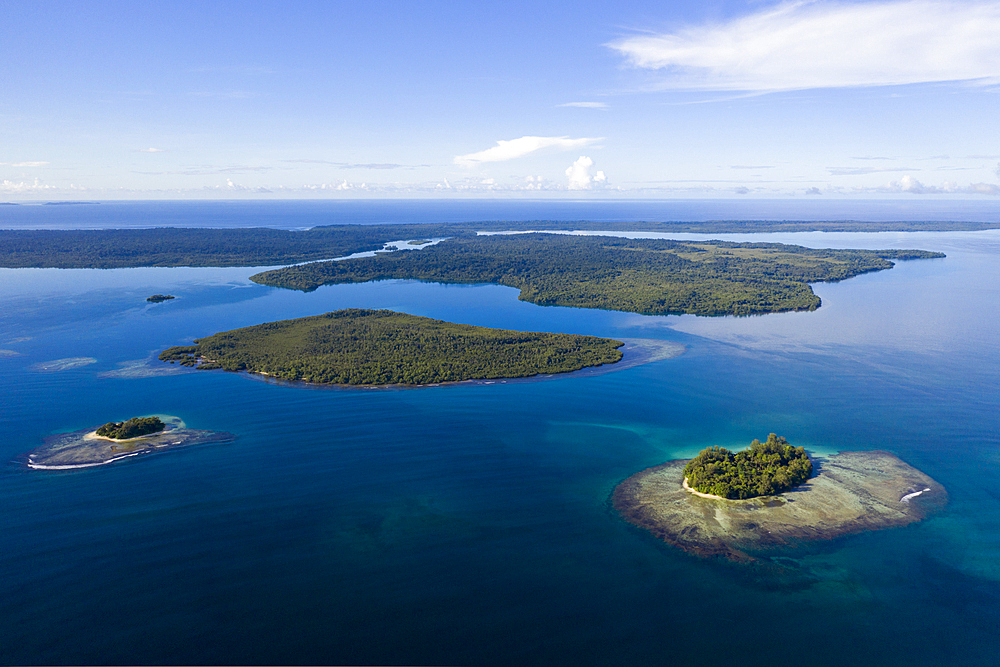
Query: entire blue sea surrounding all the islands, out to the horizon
0,200,1000,667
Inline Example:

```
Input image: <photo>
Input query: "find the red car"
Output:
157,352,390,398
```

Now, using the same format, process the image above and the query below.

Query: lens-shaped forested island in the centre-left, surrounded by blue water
160,309,623,386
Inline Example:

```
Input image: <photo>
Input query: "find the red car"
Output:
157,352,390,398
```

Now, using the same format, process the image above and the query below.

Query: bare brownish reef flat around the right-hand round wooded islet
611,451,948,562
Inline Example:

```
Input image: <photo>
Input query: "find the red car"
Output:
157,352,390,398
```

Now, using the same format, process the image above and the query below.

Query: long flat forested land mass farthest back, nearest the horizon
0,220,968,269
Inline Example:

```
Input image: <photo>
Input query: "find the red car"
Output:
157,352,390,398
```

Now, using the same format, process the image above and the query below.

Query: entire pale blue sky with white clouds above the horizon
0,0,1000,201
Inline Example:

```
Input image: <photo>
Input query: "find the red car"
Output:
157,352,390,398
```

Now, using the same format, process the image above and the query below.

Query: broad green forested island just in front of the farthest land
251,234,941,315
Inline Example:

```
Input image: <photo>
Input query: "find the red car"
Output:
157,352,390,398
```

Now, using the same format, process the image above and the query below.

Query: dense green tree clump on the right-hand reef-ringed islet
684,433,813,500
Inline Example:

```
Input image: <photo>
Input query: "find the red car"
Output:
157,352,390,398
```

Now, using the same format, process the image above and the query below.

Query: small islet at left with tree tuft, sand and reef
27,415,235,470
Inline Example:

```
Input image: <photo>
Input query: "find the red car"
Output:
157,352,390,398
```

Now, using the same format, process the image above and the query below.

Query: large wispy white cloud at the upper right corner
607,0,1000,91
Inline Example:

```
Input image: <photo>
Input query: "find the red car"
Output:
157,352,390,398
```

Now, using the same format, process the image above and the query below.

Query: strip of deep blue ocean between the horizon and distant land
0,197,1000,229
